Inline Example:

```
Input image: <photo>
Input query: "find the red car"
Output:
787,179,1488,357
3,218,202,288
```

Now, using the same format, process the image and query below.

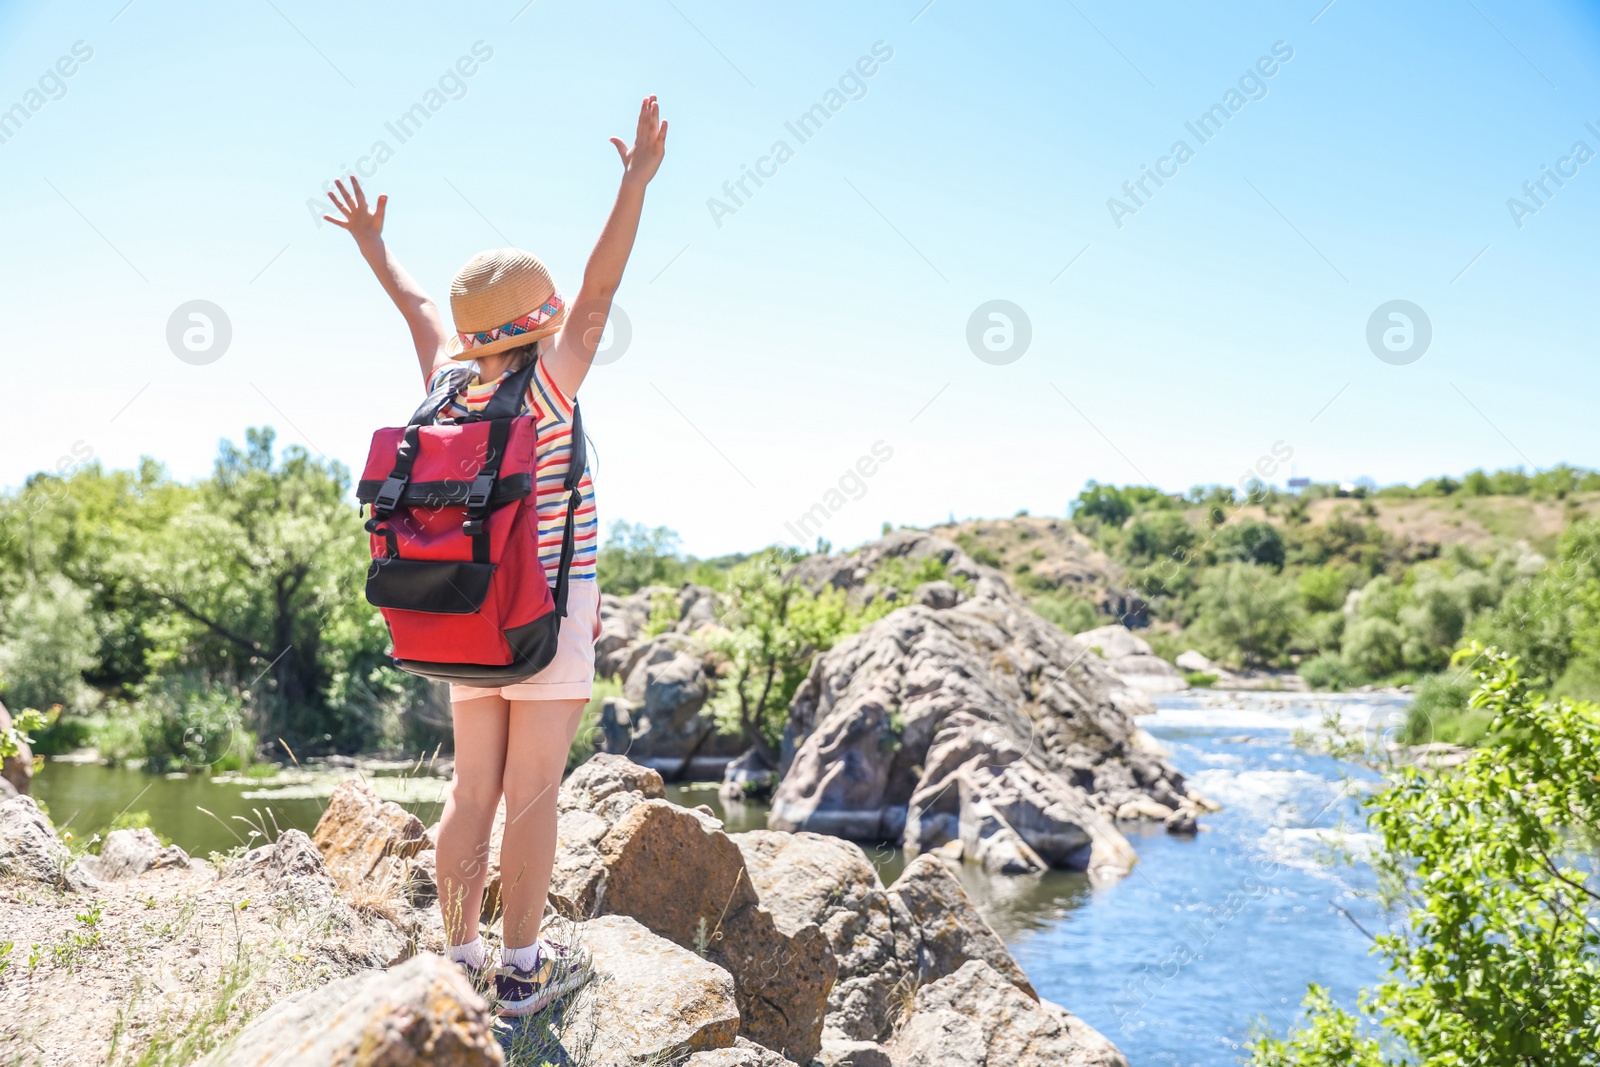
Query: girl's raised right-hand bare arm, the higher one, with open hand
544,96,667,397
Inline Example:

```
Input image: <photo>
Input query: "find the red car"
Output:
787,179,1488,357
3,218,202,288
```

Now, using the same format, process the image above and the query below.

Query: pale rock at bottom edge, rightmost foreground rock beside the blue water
886,960,1128,1067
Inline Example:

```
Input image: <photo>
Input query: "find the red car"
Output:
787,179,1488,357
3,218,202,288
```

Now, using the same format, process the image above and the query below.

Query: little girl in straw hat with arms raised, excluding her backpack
323,96,667,1016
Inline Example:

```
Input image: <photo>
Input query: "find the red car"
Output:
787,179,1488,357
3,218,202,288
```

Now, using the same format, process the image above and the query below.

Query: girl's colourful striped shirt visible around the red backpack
427,360,600,589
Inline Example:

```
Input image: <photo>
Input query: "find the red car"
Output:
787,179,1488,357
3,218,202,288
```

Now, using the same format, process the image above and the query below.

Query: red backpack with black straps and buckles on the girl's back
357,362,584,688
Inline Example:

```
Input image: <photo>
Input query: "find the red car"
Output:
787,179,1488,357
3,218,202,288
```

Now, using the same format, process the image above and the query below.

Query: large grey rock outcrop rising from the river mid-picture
768,531,1206,877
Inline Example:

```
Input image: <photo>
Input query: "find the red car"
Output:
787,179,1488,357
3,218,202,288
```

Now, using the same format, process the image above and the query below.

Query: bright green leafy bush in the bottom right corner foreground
1250,645,1600,1067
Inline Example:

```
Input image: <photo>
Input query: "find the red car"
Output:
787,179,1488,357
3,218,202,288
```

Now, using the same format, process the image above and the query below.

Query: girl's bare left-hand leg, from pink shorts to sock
437,696,510,945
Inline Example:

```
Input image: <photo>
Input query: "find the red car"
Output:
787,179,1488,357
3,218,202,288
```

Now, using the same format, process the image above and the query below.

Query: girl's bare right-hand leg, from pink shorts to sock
501,701,587,949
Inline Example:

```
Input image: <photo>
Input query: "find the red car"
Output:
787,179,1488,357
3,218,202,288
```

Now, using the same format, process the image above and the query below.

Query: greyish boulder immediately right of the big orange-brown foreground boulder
733,830,920,1041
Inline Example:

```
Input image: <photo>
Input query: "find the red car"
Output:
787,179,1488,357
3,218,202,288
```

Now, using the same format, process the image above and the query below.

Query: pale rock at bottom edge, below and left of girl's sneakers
200,955,506,1067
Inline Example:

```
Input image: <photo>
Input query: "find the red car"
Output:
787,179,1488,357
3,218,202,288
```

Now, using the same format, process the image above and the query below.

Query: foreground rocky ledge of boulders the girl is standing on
0,755,1126,1067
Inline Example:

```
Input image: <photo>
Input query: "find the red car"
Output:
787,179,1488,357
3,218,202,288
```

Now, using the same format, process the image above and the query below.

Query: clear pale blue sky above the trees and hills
0,0,1600,555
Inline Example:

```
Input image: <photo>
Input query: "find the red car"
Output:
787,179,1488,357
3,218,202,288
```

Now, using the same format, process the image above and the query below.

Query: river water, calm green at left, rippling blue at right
34,693,1403,1067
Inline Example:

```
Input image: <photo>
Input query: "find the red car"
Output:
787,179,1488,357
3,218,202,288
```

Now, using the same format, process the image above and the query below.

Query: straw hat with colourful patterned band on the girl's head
448,248,566,360
